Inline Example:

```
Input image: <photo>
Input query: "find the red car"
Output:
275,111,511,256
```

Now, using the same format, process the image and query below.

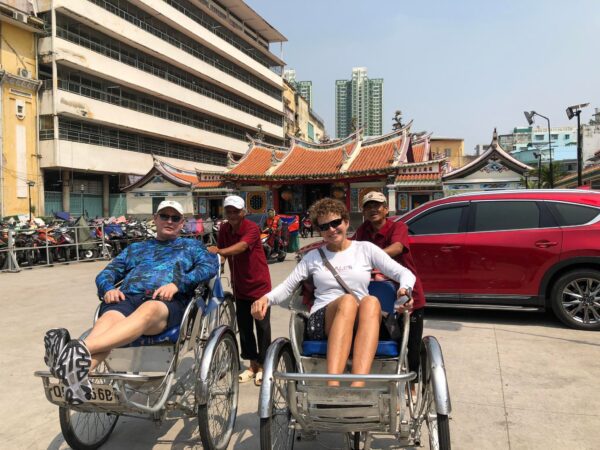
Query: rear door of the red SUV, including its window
462,200,562,298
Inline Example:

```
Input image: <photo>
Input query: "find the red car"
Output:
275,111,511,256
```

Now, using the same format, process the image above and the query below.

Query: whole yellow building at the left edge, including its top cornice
0,0,44,218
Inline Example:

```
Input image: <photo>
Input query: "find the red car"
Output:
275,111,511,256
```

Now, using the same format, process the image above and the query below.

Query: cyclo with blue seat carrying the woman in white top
258,281,451,450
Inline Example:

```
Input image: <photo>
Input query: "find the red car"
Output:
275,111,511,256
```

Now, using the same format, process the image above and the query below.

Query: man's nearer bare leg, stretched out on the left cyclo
85,301,169,362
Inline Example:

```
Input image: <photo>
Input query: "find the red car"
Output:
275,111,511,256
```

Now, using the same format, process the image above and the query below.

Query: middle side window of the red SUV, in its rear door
473,201,540,231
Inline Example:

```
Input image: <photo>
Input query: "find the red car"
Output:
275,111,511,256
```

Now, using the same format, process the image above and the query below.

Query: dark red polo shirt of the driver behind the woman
353,219,425,309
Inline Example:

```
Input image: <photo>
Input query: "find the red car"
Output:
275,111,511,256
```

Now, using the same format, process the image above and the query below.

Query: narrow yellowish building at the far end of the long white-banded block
283,79,325,142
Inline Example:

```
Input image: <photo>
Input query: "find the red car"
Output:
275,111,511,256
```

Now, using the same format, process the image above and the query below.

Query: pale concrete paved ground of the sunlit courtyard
0,243,600,450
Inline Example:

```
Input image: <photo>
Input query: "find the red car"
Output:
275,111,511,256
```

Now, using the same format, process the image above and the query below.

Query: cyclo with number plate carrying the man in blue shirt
35,264,239,450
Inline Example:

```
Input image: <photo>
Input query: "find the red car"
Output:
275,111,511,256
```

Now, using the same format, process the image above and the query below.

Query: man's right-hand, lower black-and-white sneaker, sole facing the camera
56,340,92,405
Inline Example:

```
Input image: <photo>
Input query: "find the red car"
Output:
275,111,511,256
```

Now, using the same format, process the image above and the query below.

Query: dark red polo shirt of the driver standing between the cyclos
217,218,271,301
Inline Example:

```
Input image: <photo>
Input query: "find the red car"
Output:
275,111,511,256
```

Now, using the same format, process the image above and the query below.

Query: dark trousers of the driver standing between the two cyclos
235,298,271,364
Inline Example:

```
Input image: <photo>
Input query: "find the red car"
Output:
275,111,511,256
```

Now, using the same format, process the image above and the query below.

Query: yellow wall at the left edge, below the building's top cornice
0,22,43,216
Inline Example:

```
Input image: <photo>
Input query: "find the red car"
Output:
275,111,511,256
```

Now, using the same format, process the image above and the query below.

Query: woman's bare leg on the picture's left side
325,294,358,386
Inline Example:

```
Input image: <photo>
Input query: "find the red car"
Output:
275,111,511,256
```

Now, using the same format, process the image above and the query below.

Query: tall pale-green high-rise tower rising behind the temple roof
335,67,383,138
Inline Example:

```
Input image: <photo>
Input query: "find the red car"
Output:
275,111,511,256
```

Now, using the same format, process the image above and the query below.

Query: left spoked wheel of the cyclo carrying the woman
260,345,296,450
